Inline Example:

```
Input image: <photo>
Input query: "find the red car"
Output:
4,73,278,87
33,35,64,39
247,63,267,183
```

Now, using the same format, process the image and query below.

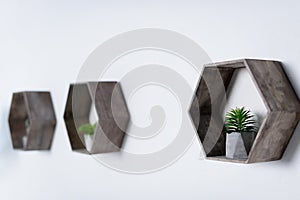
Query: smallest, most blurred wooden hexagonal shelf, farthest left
8,92,56,150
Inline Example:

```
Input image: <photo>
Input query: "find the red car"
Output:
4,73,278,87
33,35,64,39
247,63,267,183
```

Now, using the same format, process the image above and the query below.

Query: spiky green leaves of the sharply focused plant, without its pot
225,107,257,133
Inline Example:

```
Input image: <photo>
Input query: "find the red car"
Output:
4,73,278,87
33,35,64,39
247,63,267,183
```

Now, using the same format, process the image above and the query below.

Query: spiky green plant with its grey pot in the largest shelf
225,107,257,159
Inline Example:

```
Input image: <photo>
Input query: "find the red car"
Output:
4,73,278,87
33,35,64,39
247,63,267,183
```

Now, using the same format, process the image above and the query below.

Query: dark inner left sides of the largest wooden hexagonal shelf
190,66,235,156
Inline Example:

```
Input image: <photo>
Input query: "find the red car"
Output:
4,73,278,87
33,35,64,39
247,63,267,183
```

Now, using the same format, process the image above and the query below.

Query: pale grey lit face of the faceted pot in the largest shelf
226,132,248,159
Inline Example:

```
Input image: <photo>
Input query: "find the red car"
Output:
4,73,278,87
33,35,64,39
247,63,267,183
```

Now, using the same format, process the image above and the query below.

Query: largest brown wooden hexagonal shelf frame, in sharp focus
189,59,300,163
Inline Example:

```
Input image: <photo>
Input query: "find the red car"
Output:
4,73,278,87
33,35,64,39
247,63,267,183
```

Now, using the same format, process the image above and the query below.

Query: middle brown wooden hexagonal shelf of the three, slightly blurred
64,82,130,154
